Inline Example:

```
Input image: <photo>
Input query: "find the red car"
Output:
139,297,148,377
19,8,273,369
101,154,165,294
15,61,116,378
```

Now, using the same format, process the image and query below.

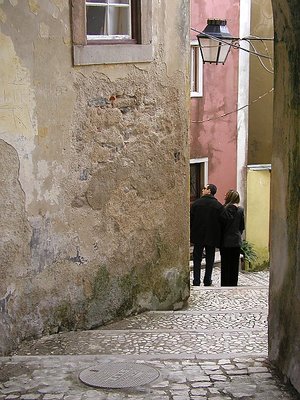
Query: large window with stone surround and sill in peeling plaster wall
71,0,153,65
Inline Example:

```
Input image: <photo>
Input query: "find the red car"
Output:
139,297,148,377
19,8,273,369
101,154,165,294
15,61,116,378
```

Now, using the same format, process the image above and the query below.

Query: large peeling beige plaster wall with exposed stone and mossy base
0,0,189,354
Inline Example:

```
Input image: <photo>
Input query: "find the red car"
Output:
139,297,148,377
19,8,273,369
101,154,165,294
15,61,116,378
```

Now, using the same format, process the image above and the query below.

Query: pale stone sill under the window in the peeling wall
73,44,153,65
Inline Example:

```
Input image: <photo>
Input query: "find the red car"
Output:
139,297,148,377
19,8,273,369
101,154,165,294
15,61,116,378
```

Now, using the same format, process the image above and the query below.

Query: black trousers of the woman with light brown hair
220,247,241,286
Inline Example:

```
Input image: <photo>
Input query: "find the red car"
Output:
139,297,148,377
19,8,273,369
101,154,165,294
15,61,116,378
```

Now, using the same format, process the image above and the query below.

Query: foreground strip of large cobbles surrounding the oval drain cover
0,355,297,400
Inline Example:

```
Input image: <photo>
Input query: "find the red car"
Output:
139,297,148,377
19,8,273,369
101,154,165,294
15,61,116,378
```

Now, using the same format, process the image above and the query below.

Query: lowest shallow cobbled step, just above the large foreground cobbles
9,329,267,356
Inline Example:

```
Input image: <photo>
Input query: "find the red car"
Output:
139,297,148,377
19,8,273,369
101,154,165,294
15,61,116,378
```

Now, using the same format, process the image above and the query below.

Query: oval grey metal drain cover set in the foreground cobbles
79,362,159,389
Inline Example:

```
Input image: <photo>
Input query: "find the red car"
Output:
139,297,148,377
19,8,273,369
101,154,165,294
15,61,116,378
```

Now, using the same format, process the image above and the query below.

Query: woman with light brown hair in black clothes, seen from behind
220,190,245,286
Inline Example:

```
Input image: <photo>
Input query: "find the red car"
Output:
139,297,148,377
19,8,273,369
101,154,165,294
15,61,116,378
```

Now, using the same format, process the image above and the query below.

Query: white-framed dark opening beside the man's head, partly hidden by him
190,157,208,203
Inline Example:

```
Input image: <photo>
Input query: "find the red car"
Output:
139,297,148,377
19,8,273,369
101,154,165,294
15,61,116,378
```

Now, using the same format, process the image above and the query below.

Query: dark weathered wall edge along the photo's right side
269,0,300,392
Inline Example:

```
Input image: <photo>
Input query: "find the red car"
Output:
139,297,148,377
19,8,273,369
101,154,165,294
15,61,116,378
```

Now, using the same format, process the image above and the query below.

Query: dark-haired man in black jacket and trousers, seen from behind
190,183,223,286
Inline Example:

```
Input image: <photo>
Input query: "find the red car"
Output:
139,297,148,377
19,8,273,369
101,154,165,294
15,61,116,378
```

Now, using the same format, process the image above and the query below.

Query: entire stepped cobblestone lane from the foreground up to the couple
0,268,299,400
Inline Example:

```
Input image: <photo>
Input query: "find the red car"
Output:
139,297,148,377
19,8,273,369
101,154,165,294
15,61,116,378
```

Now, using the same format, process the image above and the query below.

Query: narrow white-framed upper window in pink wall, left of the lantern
191,41,203,97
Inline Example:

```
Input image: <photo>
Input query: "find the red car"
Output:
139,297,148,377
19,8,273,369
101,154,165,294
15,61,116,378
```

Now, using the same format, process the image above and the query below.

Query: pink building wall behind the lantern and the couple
190,0,240,202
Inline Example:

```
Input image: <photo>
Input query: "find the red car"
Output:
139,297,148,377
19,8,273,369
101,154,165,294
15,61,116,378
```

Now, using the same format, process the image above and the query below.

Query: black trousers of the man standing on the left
193,243,215,286
